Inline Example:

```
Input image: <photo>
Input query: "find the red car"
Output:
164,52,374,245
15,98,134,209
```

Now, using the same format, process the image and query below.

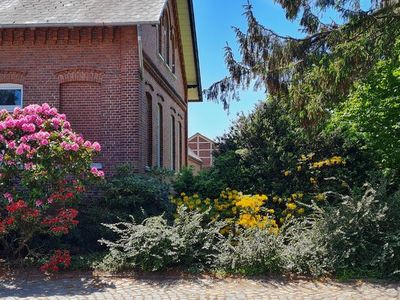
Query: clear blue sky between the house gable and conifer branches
189,0,299,139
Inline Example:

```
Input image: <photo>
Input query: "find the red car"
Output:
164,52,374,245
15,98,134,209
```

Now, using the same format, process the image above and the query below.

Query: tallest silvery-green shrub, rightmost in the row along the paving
282,187,400,277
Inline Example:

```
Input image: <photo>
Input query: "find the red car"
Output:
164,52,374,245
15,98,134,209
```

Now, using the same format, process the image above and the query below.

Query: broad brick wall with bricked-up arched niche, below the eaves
0,26,143,171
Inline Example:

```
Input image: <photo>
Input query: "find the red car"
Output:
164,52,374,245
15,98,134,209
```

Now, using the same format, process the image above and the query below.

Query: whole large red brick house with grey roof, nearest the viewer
0,0,202,172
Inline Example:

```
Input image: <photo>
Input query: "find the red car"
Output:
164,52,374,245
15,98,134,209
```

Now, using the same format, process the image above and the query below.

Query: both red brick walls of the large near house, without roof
0,5,187,172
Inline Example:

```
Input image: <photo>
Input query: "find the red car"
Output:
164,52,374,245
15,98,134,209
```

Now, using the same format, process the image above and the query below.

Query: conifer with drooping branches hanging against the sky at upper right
205,0,400,126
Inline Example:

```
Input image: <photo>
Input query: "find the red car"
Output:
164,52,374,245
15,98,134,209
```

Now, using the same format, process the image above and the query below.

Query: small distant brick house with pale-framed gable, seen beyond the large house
188,133,215,169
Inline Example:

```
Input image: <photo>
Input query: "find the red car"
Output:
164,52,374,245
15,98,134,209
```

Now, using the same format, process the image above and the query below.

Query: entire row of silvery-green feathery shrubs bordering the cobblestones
98,179,400,278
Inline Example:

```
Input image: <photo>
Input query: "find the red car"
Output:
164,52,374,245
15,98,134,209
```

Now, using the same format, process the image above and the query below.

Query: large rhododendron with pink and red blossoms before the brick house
0,104,104,269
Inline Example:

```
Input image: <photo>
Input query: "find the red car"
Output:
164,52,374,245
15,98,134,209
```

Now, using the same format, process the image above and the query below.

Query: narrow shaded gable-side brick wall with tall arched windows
142,0,187,169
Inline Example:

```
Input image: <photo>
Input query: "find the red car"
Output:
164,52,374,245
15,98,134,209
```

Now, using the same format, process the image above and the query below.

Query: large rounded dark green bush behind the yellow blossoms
200,99,376,197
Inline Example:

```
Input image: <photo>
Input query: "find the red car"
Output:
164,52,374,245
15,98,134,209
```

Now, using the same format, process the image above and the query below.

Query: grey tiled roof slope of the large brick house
0,0,166,28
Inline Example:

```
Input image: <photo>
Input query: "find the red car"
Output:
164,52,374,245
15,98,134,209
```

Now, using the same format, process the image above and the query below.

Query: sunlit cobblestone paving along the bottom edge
0,275,400,300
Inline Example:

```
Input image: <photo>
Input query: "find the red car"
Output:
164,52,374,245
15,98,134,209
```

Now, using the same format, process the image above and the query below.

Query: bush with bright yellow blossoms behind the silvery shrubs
171,154,346,234
